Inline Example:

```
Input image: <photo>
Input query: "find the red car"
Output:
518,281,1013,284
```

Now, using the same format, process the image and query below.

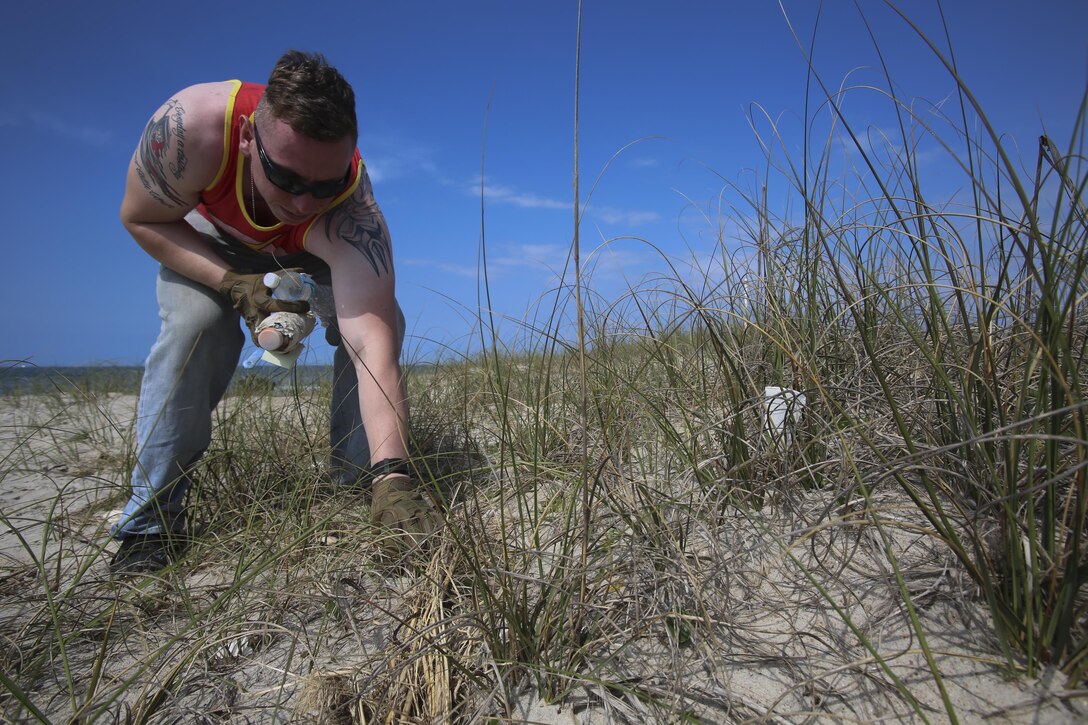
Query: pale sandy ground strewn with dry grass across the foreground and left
0,394,1088,723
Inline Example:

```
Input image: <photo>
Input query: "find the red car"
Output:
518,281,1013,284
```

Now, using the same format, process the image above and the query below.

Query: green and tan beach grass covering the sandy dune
0,4,1088,723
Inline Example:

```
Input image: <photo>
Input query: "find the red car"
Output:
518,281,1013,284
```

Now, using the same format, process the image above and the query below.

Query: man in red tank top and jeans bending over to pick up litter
111,51,441,574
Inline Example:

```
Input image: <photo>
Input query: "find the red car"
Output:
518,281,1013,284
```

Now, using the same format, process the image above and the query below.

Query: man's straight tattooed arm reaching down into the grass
306,172,408,463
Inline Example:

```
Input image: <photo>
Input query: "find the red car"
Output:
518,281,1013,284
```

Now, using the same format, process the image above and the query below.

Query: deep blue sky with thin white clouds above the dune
0,0,1088,365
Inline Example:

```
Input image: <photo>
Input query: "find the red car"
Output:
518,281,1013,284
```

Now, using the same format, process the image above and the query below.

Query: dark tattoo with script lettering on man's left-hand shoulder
134,99,188,208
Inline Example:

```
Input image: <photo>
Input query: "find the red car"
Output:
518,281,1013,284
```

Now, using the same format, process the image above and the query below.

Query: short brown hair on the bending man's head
255,50,359,143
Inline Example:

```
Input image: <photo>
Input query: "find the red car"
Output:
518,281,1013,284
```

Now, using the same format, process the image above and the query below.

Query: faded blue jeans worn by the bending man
112,214,405,539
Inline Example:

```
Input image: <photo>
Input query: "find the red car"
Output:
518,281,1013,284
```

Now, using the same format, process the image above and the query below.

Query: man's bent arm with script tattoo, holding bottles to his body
121,83,230,288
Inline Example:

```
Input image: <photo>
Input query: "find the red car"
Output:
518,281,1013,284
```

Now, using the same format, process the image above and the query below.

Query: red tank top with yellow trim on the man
197,81,363,254
